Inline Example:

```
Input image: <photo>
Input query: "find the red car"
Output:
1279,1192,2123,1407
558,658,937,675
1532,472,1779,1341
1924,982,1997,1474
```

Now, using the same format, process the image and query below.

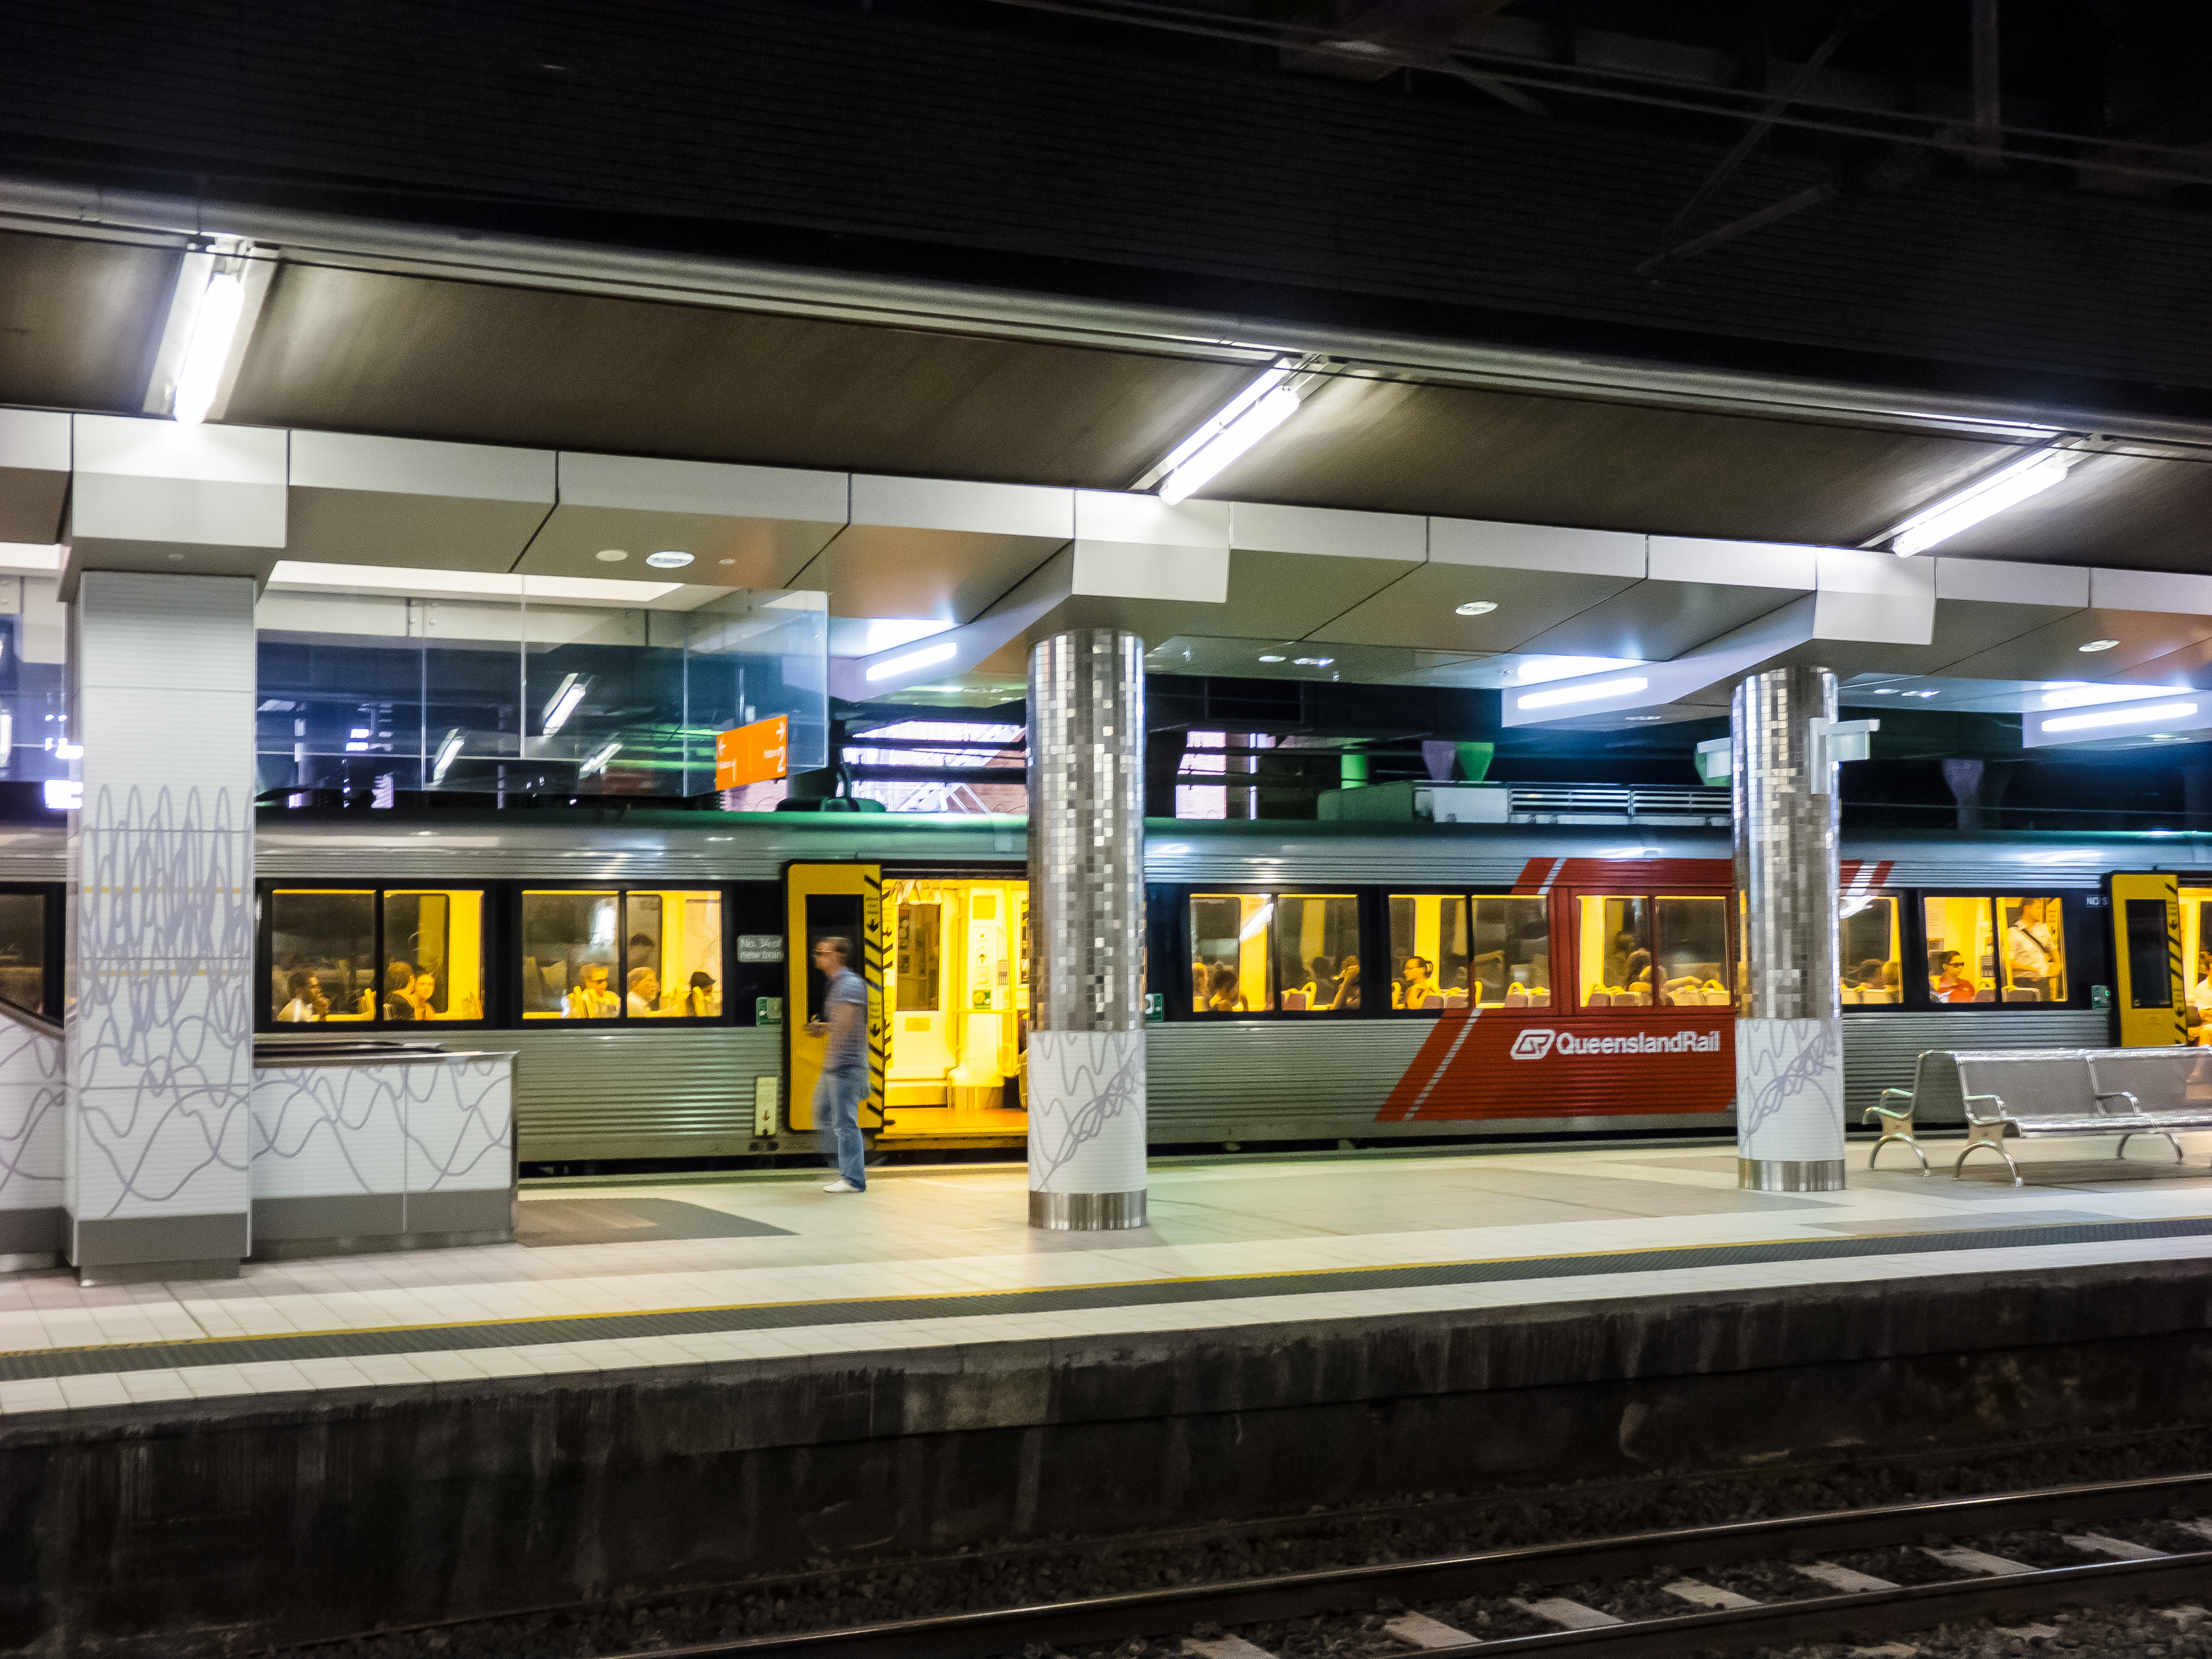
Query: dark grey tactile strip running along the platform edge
0,1217,2212,1383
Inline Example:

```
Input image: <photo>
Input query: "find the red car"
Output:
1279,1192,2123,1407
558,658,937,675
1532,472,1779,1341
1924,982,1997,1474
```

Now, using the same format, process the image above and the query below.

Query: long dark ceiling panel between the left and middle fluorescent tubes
230,265,1254,489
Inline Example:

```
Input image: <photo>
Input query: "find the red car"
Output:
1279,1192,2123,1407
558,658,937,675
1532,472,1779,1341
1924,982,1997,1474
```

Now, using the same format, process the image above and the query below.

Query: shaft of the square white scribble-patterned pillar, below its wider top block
64,571,254,1281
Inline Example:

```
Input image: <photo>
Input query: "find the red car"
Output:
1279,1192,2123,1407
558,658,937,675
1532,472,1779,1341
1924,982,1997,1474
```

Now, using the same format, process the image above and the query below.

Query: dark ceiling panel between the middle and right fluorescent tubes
1206,378,2008,546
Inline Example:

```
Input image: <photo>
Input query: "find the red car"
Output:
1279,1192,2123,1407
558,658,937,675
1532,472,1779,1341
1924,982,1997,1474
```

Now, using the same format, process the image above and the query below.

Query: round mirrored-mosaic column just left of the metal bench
1730,668,1843,1192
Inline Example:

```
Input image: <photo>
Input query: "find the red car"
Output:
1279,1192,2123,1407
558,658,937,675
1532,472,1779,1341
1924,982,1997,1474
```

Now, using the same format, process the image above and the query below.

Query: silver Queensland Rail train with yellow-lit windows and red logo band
0,807,2212,1168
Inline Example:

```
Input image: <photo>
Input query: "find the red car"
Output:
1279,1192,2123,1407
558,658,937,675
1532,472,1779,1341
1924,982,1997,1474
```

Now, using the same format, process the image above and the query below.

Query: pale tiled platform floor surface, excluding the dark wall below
0,1137,2212,1416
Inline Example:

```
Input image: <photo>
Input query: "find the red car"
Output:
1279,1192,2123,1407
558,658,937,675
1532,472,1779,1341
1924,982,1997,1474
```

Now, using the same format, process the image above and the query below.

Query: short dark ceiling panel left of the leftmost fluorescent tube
0,232,177,414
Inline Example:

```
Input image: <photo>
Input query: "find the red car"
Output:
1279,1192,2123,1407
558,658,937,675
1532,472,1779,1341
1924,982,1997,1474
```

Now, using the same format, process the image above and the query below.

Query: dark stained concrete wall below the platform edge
0,1263,2212,1655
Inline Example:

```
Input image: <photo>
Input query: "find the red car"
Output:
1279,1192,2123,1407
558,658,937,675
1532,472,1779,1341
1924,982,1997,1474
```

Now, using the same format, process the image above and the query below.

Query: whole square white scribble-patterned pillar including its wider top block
62,416,285,1283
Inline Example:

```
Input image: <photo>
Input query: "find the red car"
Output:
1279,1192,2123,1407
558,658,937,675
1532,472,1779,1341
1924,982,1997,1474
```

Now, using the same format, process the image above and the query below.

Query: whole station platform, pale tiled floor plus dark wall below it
13,1137,2212,1652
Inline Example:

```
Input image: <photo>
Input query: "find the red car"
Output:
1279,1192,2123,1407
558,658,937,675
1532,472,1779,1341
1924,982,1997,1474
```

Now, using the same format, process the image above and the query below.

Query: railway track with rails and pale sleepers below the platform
622,1473,2212,1659
